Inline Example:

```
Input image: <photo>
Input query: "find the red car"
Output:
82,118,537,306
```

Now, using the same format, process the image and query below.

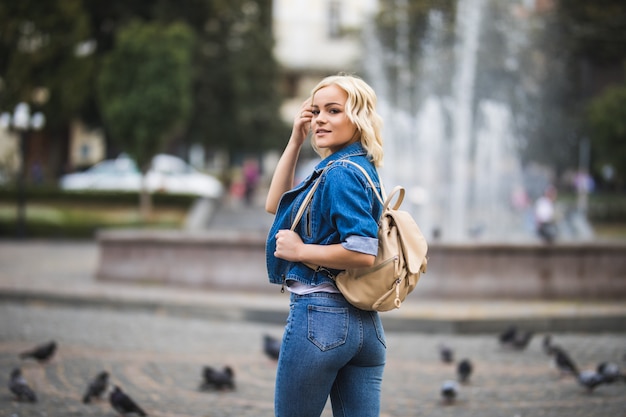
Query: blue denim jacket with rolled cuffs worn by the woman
265,142,382,286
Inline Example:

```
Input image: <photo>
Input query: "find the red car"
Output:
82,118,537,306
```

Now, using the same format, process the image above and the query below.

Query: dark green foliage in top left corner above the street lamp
0,0,95,129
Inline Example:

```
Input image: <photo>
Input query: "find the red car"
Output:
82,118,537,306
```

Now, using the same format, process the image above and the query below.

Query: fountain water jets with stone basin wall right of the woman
354,0,626,298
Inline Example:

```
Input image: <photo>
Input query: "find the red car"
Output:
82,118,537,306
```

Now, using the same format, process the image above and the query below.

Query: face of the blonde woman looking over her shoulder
311,85,359,153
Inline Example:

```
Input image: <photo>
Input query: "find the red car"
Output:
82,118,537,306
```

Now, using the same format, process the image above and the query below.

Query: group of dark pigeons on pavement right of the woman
439,326,626,404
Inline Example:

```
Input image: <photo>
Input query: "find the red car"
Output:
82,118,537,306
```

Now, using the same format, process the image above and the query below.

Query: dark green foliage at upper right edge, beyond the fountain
559,0,626,189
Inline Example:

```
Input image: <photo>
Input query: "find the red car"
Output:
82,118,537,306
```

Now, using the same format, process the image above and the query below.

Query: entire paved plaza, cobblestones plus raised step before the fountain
0,200,626,417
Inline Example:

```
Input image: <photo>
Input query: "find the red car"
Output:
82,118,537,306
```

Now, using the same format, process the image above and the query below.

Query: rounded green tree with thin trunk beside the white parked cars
97,21,194,216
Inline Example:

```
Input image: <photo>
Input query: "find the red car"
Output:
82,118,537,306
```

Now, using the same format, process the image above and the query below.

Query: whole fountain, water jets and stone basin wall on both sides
97,0,626,300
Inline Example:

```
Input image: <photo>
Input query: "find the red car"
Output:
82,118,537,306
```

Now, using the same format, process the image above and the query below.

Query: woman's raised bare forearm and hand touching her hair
265,99,313,214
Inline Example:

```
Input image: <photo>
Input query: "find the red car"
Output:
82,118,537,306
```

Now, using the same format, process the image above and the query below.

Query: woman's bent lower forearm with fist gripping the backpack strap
274,230,375,269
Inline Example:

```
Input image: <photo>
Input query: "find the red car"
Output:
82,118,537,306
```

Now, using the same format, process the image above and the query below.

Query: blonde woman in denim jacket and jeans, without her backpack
266,75,386,417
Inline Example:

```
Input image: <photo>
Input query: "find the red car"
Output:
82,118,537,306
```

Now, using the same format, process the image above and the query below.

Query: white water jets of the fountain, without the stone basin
365,0,533,242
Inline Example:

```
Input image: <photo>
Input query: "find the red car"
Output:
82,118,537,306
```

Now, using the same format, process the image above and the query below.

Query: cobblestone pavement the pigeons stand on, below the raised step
0,301,626,417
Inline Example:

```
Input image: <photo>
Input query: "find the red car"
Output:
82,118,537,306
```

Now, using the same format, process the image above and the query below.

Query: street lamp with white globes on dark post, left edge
0,103,46,238
